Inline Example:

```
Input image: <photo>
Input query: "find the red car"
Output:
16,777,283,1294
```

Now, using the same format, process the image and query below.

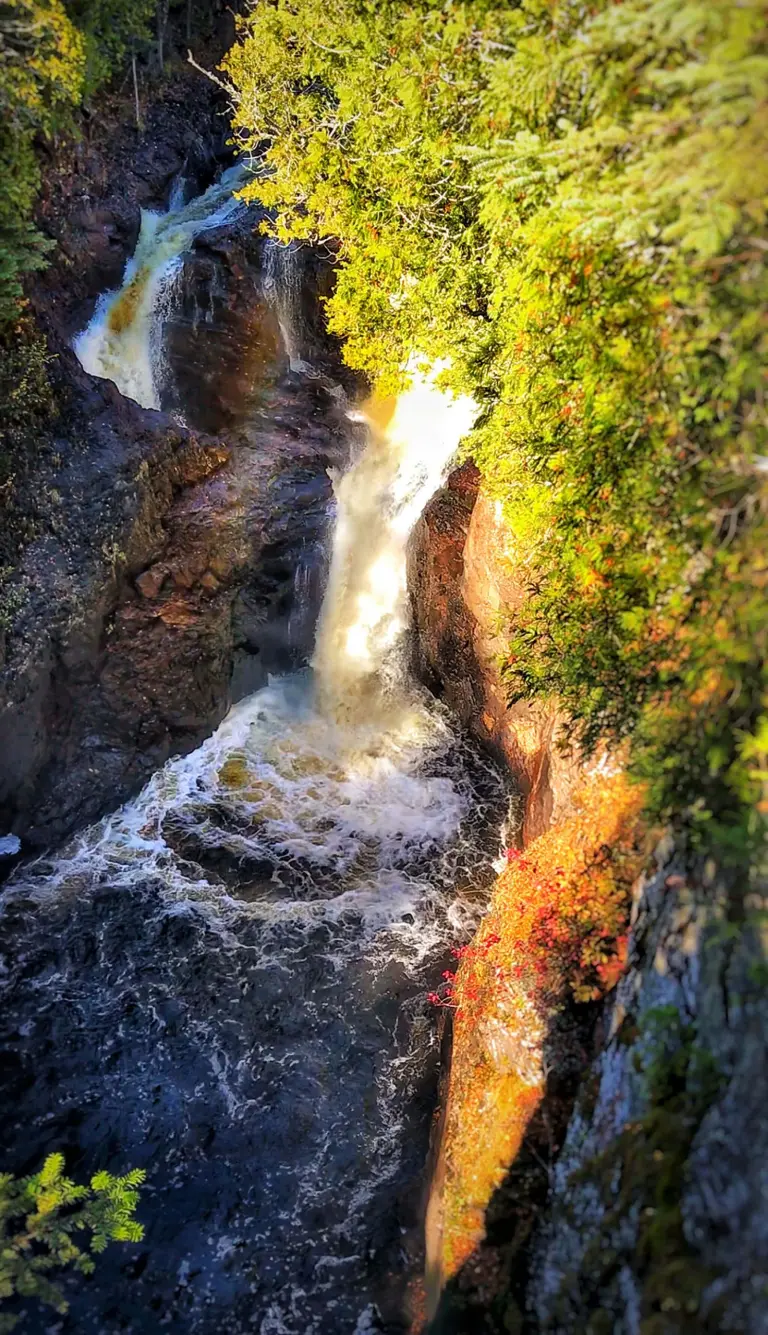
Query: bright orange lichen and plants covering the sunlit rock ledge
433,772,644,1282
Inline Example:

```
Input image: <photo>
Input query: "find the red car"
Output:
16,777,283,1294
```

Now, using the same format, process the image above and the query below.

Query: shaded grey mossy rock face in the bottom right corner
528,838,768,1335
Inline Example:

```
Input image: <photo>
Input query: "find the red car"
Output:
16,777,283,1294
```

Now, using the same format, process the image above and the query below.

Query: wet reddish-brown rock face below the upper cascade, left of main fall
0,365,346,845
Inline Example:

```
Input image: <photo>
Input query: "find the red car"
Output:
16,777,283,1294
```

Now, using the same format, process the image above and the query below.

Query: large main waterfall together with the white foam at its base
11,370,475,959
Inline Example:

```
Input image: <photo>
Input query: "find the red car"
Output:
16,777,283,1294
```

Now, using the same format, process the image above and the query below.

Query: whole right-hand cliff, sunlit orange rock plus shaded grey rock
410,465,768,1335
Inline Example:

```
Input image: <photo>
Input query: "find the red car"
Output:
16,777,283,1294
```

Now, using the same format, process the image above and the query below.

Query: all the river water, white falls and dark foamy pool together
0,172,505,1335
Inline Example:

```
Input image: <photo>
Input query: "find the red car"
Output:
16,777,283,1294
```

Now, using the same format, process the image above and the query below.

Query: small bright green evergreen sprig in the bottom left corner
0,1155,144,1331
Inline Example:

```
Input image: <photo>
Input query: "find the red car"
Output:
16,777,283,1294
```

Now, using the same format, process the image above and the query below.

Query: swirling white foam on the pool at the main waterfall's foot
7,674,470,947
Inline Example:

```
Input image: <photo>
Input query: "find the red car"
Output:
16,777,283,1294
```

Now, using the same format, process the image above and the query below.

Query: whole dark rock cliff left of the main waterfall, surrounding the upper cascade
0,76,349,861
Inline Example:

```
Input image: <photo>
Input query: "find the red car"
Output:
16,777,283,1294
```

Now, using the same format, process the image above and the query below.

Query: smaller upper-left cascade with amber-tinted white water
73,164,246,409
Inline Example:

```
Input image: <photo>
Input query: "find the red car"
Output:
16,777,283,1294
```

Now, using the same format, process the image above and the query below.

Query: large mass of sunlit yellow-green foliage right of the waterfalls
224,0,768,857
